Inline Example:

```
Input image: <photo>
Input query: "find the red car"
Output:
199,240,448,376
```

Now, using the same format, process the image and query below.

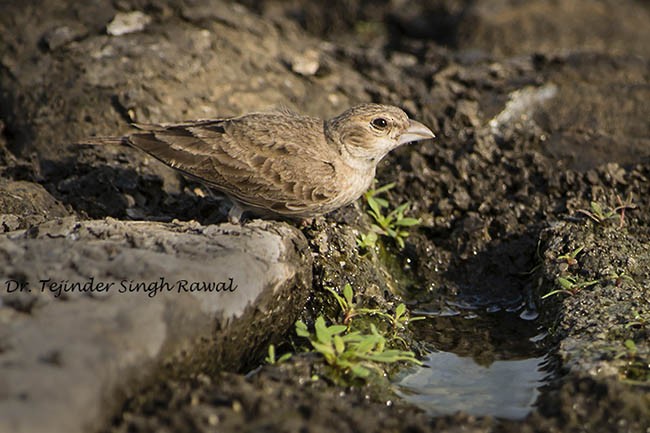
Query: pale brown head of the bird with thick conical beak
325,104,435,166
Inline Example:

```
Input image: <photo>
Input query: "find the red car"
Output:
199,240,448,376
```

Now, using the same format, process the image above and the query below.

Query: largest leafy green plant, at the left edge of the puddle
296,316,420,379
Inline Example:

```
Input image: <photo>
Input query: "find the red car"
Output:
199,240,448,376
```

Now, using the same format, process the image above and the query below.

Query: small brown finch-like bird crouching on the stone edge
113,104,434,221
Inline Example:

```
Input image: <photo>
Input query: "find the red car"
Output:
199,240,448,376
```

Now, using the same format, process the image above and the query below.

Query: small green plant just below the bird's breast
357,183,420,249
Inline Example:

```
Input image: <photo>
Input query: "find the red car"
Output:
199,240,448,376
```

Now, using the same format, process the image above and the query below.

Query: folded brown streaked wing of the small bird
129,113,338,215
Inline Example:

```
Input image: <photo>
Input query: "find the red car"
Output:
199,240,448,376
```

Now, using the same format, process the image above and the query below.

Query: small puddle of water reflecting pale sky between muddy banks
395,302,549,420
